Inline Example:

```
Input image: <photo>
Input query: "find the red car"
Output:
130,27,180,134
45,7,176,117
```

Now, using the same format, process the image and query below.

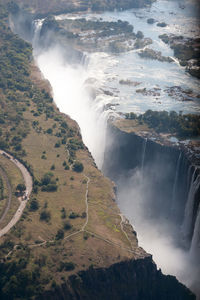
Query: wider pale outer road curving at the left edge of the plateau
0,150,33,237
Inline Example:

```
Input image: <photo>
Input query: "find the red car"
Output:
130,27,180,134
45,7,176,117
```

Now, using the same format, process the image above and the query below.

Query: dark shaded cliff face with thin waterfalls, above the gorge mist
104,123,200,260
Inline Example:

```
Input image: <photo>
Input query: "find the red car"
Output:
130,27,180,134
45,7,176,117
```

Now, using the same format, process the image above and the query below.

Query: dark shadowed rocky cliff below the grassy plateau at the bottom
37,257,195,300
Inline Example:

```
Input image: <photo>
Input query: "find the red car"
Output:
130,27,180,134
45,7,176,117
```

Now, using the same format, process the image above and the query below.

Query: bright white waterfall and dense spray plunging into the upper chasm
33,21,115,168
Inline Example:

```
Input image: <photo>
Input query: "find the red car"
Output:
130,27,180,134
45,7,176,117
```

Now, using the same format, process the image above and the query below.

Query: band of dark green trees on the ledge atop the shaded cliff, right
125,110,200,138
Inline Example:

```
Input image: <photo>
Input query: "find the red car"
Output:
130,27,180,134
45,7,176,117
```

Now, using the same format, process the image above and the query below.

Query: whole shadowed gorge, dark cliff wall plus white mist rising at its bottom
103,120,200,296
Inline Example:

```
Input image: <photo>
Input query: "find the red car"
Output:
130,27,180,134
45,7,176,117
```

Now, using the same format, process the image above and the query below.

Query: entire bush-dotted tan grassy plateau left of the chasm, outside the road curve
0,2,144,299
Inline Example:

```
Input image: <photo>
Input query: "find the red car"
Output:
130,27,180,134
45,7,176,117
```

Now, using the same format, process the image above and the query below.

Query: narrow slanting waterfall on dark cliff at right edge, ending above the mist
182,167,200,244
